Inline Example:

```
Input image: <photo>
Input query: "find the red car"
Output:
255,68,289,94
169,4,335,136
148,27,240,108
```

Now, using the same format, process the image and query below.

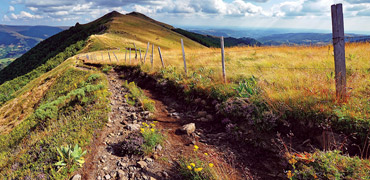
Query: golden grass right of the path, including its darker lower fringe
86,43,370,135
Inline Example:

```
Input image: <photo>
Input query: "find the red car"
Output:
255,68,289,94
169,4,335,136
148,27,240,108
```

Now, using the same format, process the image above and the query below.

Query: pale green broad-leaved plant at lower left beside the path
54,144,86,172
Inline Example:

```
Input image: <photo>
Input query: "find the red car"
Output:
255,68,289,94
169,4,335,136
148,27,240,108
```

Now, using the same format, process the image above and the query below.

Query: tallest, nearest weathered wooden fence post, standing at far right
331,4,346,101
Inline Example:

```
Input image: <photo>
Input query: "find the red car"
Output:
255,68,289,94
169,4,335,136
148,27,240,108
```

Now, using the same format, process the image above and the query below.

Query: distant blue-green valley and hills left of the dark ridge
0,25,67,69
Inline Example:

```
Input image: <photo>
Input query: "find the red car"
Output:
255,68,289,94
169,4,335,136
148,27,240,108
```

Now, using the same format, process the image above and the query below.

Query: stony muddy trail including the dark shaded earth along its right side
80,68,286,180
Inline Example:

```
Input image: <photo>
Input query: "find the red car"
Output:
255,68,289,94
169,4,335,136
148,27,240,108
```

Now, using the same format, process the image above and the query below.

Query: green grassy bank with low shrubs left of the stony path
0,59,109,179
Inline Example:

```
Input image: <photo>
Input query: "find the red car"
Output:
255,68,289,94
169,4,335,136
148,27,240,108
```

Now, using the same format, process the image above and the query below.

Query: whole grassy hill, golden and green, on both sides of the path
0,12,370,179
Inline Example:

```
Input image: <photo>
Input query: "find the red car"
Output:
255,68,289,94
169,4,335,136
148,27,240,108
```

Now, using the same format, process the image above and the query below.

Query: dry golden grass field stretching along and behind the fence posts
82,43,370,120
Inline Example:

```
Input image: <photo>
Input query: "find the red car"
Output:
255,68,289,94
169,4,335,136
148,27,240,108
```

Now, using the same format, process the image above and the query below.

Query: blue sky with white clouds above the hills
0,0,370,32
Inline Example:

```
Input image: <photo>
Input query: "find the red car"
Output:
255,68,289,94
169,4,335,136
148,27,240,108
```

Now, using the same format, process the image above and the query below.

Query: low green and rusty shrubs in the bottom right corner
287,151,370,180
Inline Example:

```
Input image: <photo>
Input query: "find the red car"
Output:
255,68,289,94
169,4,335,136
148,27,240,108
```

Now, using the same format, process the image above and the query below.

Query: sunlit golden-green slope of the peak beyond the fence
83,11,204,51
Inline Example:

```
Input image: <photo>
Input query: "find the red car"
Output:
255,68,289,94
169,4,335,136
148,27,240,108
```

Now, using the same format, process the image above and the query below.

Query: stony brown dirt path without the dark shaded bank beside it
80,70,252,180
